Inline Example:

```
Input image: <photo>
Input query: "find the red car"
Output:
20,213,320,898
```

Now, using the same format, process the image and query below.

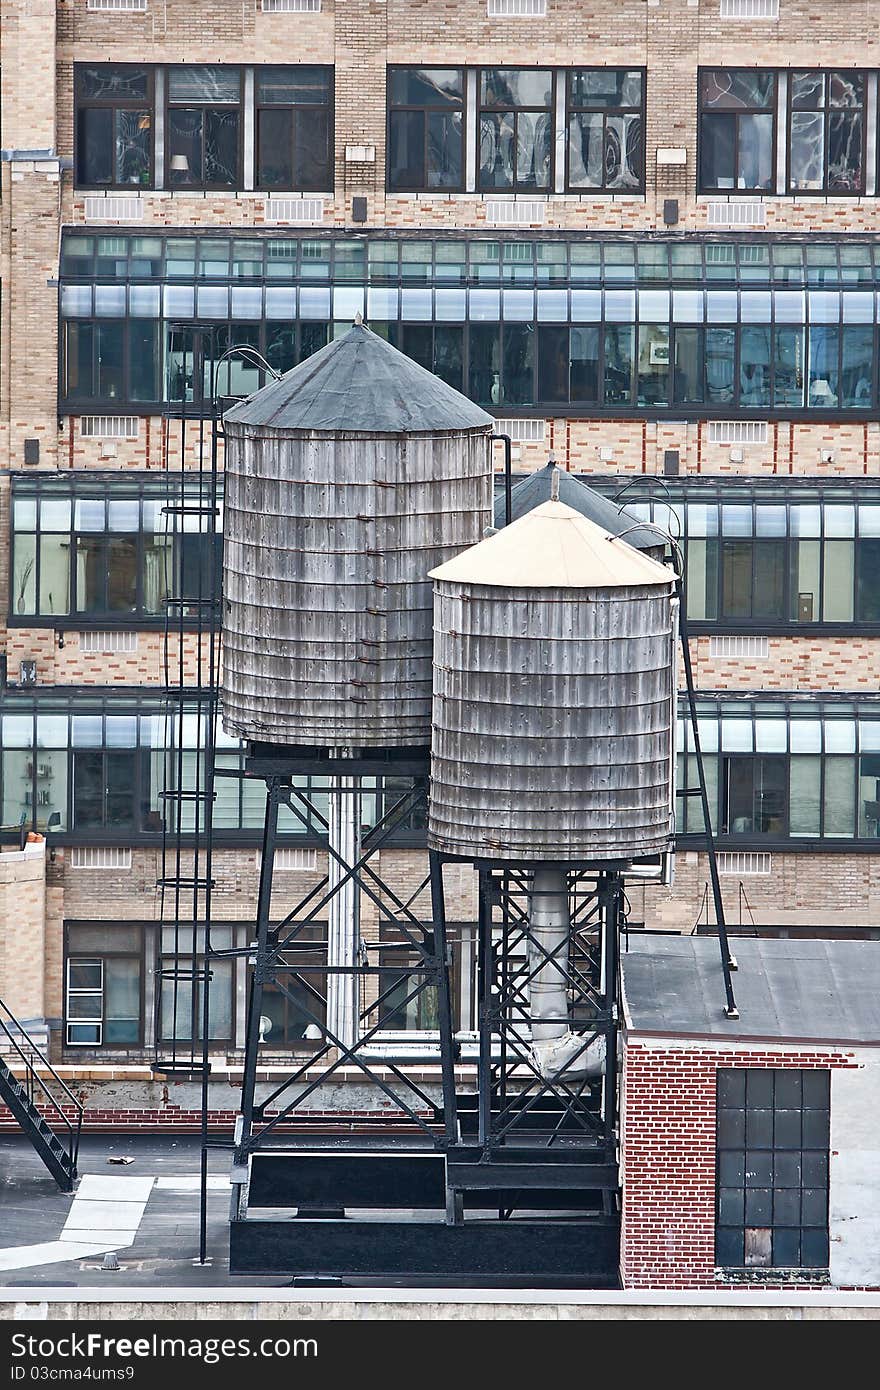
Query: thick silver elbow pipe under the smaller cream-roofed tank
528,865,605,1081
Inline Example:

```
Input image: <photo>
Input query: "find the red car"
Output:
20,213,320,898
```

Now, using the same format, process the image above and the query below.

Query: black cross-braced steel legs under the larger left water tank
226,749,455,1165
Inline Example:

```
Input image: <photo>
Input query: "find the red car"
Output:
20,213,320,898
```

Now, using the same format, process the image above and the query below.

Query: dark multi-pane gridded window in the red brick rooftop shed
715,1068,831,1269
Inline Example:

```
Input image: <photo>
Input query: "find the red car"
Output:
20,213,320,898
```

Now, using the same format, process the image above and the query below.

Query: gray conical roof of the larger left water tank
225,324,492,435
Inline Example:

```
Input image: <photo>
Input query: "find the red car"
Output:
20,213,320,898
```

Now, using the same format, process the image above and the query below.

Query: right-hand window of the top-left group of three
256,67,334,192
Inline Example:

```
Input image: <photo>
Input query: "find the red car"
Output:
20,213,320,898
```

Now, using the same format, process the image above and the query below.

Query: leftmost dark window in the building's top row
74,64,153,188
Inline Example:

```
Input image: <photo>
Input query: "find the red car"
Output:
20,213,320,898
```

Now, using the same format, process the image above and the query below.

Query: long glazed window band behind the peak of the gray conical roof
61,225,880,411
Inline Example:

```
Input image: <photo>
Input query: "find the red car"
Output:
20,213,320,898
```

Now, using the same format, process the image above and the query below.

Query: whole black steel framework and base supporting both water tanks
222,745,623,1289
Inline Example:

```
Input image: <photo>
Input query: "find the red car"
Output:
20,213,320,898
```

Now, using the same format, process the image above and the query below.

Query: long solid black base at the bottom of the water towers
229,1216,620,1289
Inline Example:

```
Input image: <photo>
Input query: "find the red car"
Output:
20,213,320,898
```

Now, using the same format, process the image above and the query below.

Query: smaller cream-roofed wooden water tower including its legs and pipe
428,492,678,1150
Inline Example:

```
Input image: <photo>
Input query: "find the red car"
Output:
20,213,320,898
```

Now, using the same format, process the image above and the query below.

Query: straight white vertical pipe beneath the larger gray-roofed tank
327,767,361,1047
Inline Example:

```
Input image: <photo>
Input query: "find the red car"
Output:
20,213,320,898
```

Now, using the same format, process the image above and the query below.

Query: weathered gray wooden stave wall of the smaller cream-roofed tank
428,580,676,862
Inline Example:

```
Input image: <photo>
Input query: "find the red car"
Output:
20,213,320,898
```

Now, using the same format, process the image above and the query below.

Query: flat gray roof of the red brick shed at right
621,935,880,1045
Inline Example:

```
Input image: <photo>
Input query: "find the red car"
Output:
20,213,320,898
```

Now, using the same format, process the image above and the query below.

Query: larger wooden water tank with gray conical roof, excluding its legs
222,324,492,748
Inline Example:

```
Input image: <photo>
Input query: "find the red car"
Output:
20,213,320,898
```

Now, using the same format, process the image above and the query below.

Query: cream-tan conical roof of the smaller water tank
430,502,674,589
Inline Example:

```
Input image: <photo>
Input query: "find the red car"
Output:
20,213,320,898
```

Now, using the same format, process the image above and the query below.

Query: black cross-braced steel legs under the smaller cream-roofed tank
430,851,626,1188
